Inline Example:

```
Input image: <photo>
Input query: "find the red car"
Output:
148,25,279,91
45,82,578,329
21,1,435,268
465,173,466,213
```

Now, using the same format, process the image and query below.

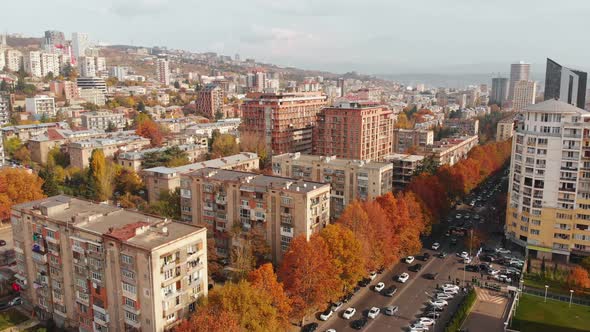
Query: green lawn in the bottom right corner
512,294,590,332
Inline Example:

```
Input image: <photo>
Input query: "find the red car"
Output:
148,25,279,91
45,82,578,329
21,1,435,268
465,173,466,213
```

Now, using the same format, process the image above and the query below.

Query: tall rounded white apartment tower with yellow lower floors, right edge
506,99,590,261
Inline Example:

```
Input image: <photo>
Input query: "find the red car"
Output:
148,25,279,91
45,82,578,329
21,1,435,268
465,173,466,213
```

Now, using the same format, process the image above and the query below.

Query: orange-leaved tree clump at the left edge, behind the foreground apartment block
0,168,45,220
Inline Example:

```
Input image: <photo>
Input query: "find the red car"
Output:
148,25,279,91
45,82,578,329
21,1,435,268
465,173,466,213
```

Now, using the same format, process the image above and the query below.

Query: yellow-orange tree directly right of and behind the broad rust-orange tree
320,224,367,292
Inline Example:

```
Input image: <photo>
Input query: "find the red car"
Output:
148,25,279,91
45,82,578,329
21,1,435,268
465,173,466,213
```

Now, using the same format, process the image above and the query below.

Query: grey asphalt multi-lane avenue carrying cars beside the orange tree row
308,169,512,332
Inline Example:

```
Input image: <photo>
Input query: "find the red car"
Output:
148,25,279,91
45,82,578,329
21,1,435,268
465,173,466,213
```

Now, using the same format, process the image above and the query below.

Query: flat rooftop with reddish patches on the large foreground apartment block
13,195,206,250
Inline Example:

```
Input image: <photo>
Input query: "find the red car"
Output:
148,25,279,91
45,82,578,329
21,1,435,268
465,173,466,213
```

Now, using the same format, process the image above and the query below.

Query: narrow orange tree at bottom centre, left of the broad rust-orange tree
248,263,292,330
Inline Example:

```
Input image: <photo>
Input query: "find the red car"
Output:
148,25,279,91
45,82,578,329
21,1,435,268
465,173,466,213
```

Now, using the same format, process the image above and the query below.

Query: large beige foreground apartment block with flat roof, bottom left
11,195,207,332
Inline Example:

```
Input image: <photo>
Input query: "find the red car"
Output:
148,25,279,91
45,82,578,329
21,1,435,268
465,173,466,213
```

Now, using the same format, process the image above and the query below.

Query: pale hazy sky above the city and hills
0,0,590,74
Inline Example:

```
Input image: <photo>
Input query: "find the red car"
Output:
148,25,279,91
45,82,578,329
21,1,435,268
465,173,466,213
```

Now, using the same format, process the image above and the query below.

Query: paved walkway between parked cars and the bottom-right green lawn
462,288,510,332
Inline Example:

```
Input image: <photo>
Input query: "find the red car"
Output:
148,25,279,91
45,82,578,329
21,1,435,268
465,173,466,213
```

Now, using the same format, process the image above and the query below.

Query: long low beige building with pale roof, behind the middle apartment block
141,152,260,203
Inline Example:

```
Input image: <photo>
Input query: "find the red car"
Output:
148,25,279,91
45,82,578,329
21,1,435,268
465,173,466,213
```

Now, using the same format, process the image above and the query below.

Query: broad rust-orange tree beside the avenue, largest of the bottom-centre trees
279,235,342,324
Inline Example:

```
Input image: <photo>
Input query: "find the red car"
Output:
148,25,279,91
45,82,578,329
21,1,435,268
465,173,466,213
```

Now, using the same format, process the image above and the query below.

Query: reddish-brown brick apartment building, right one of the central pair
313,102,395,161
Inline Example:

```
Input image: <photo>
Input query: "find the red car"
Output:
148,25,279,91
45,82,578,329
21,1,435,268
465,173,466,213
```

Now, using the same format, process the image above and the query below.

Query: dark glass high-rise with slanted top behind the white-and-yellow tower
545,58,588,109
